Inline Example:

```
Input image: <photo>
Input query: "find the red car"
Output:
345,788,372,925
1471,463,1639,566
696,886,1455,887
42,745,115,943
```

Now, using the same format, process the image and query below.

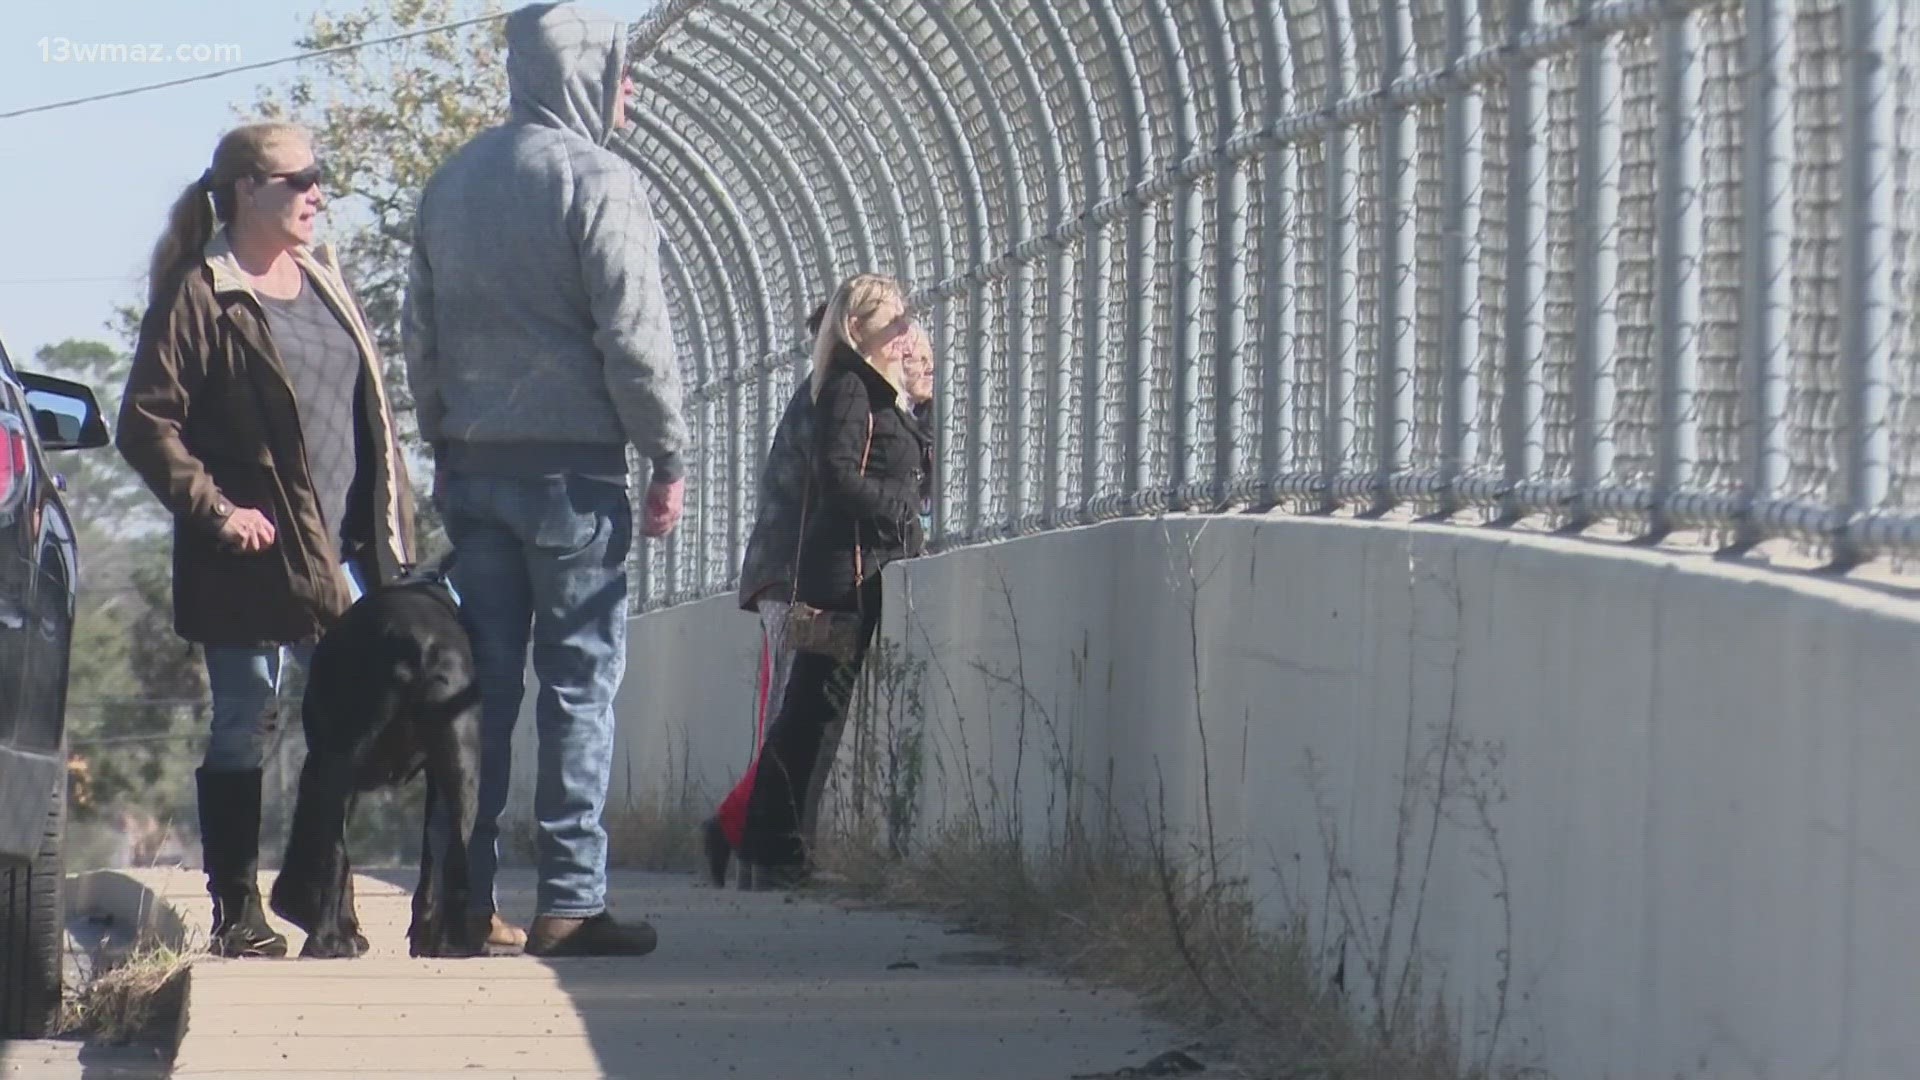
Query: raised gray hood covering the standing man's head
507,4,626,146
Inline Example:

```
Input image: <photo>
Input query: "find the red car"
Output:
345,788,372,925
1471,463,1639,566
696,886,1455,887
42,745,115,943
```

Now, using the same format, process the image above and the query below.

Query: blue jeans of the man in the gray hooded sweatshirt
434,473,634,919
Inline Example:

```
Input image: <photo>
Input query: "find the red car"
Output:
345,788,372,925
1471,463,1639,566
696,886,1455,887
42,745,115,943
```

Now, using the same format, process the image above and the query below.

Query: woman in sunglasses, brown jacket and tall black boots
115,123,413,955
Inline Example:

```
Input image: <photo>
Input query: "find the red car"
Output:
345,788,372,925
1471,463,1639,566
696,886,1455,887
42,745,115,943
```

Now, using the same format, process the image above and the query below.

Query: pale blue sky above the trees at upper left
0,0,653,363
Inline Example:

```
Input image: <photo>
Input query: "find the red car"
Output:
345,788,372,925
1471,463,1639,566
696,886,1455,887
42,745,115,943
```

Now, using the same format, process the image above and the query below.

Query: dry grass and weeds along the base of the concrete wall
820,828,1476,1080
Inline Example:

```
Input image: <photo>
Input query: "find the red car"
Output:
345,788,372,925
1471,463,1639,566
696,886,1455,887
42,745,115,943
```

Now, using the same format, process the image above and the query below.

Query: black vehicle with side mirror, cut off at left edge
0,332,109,1038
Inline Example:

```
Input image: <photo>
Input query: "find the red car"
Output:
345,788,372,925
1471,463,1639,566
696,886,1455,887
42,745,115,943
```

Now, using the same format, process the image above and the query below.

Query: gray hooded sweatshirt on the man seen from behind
401,4,687,480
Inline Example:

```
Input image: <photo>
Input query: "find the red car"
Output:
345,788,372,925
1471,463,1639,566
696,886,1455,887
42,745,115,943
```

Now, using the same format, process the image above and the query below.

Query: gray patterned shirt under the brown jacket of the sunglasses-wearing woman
259,273,361,546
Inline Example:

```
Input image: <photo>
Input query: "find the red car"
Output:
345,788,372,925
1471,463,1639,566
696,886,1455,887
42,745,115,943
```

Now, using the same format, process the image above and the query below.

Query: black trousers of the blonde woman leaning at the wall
739,575,879,867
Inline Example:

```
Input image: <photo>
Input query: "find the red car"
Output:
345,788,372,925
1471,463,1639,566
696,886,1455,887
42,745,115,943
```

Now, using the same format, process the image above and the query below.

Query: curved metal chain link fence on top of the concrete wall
616,0,1920,605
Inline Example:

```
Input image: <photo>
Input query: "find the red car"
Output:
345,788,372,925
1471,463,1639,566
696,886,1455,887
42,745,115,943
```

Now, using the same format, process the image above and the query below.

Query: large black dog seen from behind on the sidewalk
273,577,480,957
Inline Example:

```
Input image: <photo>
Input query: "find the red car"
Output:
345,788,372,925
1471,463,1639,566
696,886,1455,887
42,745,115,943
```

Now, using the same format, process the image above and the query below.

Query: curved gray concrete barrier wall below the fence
556,517,1920,1078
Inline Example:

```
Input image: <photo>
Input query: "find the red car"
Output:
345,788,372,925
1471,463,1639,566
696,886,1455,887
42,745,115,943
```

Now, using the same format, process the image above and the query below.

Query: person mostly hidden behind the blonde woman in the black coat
701,304,933,888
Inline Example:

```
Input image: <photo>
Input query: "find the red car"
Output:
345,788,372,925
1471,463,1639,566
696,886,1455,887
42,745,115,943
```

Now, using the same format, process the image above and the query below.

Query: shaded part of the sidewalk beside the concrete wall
367,869,1179,1080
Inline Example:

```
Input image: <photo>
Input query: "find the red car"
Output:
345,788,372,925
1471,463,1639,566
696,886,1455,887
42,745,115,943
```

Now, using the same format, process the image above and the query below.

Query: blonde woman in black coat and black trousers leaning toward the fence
739,275,931,888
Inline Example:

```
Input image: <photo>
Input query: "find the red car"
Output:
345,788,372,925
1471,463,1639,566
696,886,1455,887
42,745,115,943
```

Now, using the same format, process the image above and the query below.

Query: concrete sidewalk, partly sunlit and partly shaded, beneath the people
152,871,1181,1080
